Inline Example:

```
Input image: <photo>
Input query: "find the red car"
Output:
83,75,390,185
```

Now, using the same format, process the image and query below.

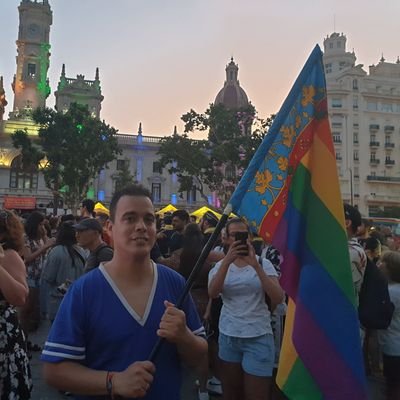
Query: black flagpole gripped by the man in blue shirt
149,204,232,362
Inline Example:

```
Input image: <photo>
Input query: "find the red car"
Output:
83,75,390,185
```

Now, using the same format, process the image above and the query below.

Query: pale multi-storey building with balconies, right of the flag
324,33,400,216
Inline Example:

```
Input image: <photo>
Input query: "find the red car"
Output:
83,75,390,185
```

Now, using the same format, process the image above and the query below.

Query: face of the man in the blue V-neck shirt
109,196,156,255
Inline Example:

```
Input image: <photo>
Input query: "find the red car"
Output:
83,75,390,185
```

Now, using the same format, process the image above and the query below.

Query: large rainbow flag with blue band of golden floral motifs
230,46,367,400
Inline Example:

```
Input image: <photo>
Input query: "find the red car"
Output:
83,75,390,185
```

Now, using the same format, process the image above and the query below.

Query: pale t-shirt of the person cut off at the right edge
378,283,400,356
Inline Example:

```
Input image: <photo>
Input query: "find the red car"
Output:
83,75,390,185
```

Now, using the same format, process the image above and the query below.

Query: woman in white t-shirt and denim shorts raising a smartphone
208,218,284,400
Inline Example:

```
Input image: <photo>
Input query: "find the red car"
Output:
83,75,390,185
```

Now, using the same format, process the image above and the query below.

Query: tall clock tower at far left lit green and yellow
10,0,53,119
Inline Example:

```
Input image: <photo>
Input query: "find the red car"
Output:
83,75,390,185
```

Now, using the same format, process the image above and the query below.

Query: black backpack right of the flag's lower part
358,258,394,329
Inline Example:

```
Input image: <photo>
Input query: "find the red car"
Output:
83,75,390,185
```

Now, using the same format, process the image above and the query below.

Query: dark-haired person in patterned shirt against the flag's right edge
344,204,367,304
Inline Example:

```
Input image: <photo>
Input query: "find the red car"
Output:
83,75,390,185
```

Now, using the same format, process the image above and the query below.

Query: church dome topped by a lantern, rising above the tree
214,58,249,109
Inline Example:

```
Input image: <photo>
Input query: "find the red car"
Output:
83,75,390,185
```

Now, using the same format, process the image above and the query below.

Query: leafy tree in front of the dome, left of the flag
159,104,274,205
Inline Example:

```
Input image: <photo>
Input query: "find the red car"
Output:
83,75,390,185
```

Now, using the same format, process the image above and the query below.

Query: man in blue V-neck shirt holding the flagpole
42,185,207,400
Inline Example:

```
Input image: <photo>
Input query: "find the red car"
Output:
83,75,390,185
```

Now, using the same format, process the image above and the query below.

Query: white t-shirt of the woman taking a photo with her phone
208,259,278,338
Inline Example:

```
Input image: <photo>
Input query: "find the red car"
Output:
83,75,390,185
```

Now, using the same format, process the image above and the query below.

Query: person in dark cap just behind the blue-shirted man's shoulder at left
74,218,113,272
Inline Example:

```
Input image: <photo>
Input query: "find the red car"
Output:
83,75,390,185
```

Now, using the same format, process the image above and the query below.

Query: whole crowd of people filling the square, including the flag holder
0,185,400,400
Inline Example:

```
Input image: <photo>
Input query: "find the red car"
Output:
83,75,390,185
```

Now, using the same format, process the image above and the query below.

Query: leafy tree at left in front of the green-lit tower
12,104,121,209
